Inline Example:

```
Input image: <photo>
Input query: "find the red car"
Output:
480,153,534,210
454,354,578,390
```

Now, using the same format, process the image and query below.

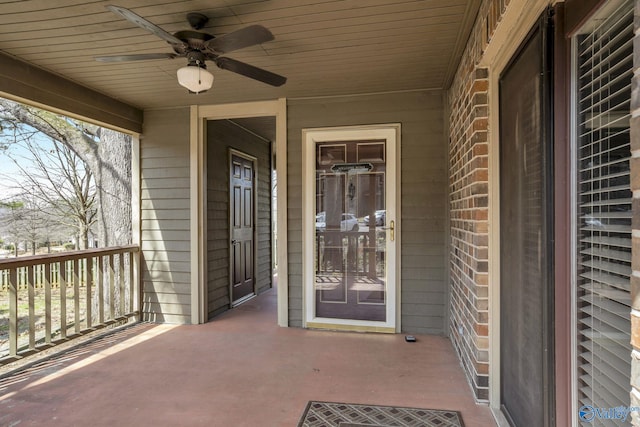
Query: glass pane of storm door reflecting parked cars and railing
314,139,384,322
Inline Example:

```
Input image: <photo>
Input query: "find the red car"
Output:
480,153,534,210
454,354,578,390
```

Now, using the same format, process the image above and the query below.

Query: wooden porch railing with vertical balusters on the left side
0,245,141,365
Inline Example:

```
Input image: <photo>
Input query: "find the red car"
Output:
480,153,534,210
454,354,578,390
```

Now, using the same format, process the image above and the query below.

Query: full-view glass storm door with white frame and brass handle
305,125,397,329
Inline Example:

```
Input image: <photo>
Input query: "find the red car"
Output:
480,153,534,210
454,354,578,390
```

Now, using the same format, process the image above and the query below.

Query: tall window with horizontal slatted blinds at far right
574,0,633,426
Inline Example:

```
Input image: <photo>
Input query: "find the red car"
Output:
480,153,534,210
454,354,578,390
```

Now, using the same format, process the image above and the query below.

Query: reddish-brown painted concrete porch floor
0,291,495,427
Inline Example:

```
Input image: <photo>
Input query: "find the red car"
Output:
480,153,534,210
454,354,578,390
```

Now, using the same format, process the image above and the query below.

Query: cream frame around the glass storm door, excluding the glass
302,123,402,333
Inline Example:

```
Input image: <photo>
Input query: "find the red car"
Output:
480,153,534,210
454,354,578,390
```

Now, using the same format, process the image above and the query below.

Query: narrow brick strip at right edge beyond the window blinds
631,0,640,426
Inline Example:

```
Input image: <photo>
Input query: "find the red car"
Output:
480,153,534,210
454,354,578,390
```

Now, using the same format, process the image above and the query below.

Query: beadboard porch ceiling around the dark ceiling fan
0,0,480,109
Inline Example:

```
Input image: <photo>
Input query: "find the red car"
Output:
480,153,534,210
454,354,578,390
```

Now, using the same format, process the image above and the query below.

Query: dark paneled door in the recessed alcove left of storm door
230,154,255,305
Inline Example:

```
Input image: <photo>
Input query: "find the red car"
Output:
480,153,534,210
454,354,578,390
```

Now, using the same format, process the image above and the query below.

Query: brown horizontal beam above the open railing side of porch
0,52,143,133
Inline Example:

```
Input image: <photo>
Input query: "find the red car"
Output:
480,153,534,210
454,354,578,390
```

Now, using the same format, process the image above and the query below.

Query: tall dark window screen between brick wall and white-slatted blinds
500,20,552,427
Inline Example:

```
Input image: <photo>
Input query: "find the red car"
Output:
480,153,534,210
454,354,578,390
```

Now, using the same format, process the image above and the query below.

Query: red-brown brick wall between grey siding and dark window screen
448,0,509,402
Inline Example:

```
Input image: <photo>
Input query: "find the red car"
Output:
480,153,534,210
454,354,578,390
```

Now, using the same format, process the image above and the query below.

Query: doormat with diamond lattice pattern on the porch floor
298,401,464,427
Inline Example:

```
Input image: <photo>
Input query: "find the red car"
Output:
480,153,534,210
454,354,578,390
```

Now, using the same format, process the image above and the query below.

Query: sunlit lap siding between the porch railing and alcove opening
140,108,191,323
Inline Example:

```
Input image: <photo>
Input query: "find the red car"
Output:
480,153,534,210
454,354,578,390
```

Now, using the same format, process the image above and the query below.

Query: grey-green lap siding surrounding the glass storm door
287,91,448,334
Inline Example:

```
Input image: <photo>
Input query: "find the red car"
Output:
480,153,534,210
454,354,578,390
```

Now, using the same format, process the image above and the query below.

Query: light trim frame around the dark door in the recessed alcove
227,148,258,308
